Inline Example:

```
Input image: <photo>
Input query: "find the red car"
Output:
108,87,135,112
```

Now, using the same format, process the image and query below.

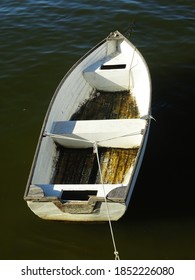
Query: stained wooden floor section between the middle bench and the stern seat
52,146,138,184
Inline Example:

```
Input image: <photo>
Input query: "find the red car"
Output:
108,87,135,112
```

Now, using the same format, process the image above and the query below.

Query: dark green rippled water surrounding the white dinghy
0,0,195,259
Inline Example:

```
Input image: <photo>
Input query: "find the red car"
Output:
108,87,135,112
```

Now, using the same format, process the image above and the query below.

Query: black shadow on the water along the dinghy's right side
135,62,195,217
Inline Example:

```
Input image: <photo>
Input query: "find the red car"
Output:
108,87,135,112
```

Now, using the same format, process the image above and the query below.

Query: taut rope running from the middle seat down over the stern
93,142,120,260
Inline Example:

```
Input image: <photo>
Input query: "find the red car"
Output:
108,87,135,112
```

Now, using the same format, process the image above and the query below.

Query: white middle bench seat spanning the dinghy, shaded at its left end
47,119,146,148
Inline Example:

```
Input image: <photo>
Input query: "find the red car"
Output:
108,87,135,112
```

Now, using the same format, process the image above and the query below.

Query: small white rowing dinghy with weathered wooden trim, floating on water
24,31,151,222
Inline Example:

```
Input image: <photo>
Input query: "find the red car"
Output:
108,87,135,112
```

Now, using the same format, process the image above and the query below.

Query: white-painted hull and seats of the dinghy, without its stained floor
24,32,151,222
